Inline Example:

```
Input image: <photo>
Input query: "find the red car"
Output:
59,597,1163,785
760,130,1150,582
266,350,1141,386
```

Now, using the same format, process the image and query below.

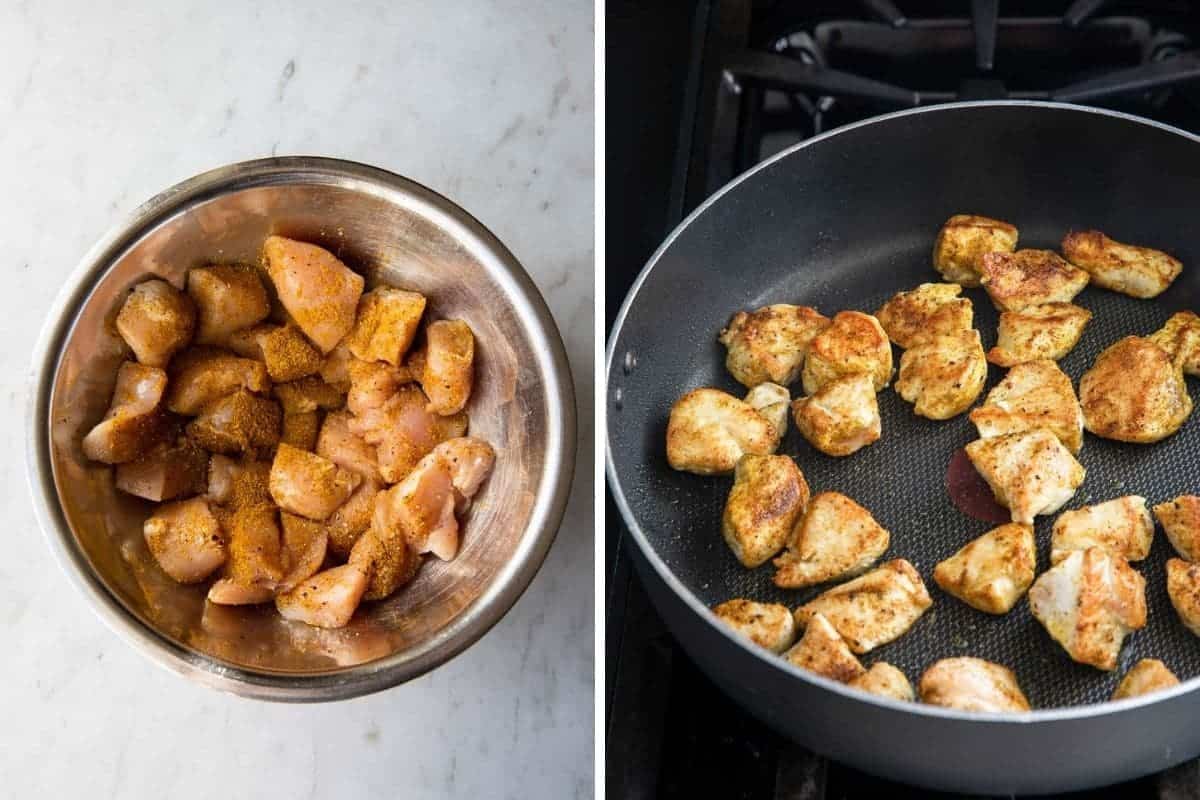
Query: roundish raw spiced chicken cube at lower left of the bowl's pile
142,498,226,583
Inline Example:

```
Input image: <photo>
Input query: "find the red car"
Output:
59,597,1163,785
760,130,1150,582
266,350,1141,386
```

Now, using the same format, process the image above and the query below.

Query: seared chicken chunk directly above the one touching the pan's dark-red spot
971,361,1084,453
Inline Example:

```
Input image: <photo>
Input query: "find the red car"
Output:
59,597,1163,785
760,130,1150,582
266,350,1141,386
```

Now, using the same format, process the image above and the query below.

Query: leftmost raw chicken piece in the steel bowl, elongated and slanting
83,361,167,464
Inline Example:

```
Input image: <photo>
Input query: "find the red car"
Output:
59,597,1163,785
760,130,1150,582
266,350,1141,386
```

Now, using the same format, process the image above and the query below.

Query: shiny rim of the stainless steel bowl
25,156,576,703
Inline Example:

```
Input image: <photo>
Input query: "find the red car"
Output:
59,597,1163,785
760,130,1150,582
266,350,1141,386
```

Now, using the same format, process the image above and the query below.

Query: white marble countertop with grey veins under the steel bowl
0,0,593,800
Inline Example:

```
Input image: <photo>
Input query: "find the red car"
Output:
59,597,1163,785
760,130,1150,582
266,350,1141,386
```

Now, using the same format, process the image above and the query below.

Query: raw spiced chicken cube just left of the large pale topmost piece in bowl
187,264,271,344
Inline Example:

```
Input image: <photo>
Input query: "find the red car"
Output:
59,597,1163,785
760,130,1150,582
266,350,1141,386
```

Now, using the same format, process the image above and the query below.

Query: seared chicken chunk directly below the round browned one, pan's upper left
792,372,883,456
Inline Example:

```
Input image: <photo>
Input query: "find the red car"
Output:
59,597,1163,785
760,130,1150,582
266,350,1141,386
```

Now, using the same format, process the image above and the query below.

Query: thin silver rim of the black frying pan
604,100,1200,726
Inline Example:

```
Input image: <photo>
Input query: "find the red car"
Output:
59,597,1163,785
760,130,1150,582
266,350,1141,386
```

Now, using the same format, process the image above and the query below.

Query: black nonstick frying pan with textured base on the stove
606,102,1200,793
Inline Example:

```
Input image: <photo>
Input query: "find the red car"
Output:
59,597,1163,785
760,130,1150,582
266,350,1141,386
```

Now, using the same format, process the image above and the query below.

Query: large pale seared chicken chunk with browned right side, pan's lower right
1030,547,1146,672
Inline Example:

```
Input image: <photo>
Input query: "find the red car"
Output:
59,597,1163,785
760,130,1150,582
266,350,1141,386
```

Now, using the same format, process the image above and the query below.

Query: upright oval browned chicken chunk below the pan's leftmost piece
721,456,809,569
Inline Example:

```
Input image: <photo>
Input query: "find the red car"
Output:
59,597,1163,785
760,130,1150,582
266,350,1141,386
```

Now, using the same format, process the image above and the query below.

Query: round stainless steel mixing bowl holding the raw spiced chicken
26,157,575,702
